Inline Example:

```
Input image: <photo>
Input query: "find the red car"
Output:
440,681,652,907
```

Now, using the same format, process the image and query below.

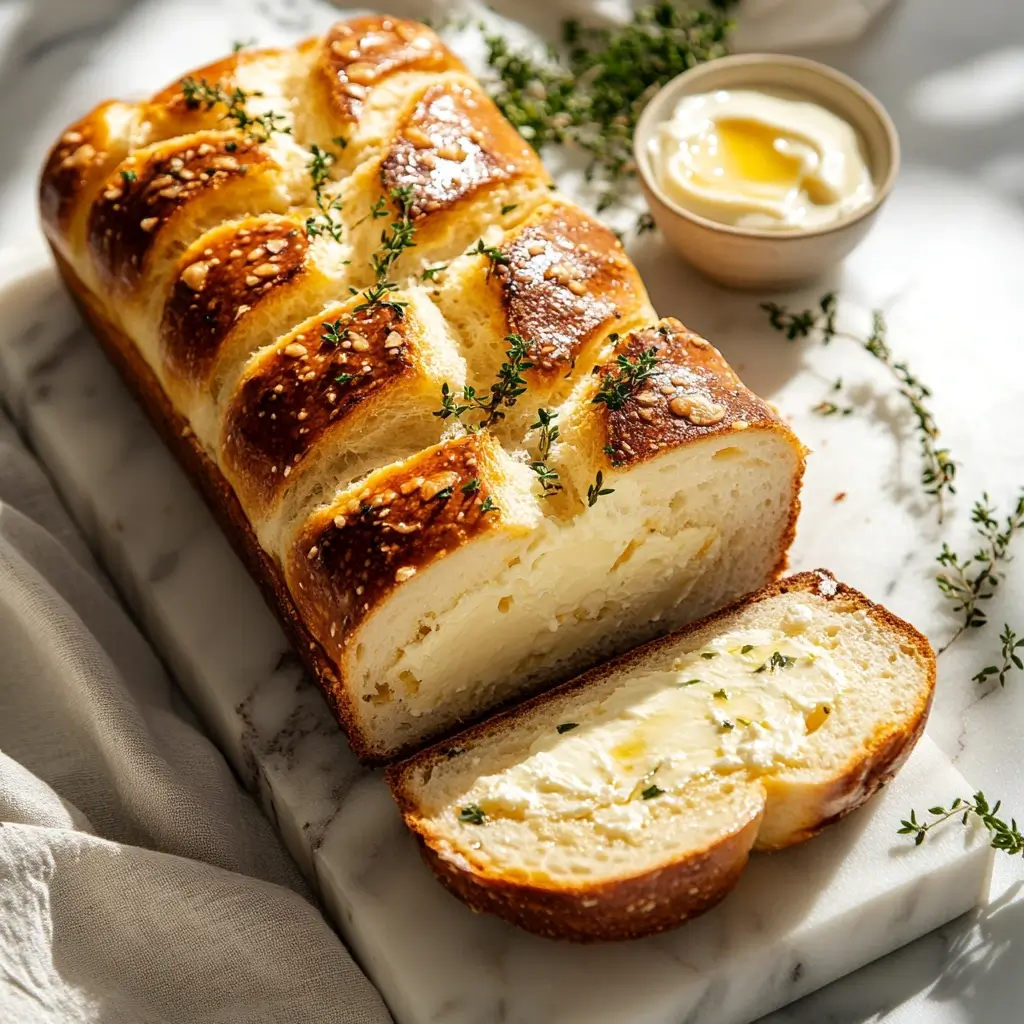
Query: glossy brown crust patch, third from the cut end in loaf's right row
380,82,547,225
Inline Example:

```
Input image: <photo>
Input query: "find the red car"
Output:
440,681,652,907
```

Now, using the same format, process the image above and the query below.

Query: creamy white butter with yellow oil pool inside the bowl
647,89,876,231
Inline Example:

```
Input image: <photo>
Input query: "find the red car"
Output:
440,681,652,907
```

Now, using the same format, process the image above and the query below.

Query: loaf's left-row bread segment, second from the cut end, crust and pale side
220,291,465,557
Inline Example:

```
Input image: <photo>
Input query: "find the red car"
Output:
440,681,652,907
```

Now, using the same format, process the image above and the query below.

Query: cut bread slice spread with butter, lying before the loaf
387,570,935,941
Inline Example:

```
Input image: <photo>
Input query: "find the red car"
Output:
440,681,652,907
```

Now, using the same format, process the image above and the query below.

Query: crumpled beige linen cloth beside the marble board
0,416,390,1024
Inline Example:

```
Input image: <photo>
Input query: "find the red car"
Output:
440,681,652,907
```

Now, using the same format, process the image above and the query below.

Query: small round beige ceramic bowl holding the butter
633,53,899,290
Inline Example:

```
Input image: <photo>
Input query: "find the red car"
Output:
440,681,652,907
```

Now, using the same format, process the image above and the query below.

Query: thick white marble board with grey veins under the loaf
0,249,991,1024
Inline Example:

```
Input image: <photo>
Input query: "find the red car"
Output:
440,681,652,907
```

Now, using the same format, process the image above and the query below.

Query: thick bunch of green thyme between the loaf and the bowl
484,0,732,210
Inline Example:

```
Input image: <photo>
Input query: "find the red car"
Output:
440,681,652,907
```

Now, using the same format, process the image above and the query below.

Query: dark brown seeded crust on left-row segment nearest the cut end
285,434,503,665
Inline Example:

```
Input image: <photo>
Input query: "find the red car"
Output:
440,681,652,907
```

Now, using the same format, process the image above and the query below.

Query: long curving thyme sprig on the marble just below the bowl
761,292,956,523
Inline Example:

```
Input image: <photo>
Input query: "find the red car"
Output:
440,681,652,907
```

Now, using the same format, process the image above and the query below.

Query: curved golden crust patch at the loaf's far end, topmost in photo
312,14,466,134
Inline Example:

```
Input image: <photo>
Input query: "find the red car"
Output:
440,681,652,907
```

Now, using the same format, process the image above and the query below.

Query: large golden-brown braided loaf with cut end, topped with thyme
41,16,804,761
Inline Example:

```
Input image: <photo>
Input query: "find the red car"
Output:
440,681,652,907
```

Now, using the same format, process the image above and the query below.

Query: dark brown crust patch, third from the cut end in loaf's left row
160,216,309,387
